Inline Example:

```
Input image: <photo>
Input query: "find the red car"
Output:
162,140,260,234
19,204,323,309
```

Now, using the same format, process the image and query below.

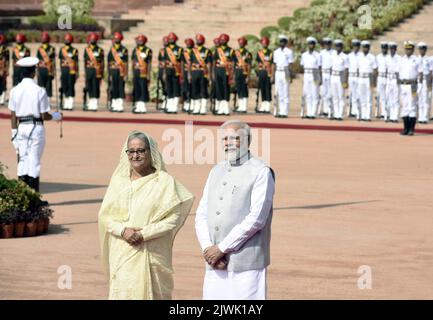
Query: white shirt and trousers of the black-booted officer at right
398,54,422,118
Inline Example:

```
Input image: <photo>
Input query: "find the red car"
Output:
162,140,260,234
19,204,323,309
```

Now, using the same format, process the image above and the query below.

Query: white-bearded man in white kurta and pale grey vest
195,120,275,300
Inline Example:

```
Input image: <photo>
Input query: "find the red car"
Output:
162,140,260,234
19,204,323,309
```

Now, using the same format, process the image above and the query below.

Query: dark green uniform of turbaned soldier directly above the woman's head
131,45,152,102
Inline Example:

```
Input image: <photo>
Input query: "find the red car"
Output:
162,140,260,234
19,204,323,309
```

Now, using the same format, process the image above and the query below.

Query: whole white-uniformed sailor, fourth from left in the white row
329,39,349,121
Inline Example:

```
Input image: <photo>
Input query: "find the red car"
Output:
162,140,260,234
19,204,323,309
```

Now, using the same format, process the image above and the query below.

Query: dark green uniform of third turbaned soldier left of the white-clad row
213,45,235,101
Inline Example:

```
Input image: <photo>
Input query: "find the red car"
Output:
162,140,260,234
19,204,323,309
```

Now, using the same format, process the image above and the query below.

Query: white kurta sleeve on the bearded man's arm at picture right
218,167,275,253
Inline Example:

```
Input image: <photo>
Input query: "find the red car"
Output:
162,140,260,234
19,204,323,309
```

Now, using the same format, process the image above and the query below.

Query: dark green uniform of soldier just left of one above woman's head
107,44,129,99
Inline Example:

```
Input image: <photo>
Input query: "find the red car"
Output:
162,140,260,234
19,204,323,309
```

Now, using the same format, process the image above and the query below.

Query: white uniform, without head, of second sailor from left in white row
301,51,322,117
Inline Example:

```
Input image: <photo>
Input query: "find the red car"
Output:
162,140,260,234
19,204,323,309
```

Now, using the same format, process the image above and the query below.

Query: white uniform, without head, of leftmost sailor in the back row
274,47,294,116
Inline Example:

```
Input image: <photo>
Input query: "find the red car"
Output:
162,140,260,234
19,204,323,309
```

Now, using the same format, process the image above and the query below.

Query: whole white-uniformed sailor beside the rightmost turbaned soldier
273,35,293,118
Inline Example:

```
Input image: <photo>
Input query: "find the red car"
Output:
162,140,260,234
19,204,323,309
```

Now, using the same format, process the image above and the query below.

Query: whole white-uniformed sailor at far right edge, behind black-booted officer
418,42,433,124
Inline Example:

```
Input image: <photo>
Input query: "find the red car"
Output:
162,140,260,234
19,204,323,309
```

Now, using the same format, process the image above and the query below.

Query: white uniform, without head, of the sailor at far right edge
418,55,433,122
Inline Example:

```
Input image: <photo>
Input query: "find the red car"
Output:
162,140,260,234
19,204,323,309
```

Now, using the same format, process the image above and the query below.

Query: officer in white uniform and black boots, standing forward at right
398,41,422,136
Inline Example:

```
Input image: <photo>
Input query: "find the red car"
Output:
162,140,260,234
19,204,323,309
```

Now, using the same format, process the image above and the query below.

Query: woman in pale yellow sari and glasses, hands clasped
99,131,194,299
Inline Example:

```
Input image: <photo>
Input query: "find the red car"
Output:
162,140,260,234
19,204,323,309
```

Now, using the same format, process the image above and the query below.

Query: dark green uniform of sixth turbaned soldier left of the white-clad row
163,44,183,99
